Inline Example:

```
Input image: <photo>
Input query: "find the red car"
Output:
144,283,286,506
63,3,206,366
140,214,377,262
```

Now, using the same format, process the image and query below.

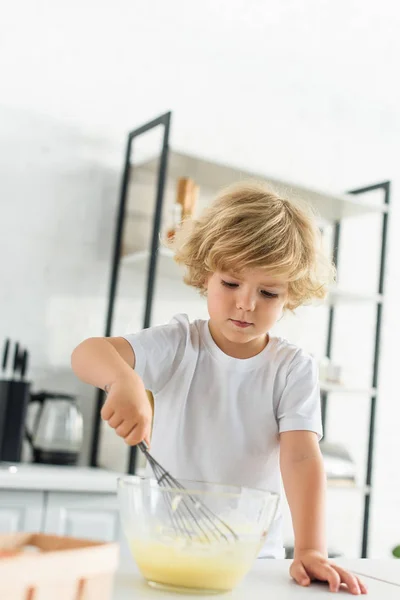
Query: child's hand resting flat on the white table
290,550,367,594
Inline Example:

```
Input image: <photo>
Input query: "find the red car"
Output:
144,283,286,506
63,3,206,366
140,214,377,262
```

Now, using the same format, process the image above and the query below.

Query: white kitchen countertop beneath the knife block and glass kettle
0,462,122,493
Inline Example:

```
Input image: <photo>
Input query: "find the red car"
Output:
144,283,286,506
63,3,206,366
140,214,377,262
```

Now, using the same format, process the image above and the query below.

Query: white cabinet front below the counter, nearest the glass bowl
44,492,122,542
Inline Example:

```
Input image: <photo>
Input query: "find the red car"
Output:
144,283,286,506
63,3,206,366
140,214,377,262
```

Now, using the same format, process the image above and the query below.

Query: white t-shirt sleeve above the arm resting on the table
276,352,322,440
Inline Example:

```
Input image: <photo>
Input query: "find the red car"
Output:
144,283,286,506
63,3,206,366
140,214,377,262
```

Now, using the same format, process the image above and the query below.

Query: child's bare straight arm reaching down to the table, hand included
280,431,366,594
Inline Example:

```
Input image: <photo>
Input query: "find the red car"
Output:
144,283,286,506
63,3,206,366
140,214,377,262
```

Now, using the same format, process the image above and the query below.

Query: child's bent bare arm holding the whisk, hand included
71,337,152,445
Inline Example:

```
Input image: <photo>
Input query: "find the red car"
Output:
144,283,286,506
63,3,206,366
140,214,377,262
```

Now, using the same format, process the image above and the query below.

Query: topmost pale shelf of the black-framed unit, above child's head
133,150,387,222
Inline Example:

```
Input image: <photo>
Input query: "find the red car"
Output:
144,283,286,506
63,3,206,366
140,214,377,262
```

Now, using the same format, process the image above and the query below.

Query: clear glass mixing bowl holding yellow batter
118,475,279,593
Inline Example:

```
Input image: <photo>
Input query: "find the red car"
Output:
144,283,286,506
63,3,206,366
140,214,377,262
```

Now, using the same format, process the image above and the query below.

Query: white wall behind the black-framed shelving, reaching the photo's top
0,0,400,556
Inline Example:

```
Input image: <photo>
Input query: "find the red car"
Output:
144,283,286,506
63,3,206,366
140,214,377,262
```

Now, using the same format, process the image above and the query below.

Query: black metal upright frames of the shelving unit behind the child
90,112,390,558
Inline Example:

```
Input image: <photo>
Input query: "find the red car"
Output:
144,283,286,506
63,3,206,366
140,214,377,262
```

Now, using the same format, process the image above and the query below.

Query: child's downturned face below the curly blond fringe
207,269,288,358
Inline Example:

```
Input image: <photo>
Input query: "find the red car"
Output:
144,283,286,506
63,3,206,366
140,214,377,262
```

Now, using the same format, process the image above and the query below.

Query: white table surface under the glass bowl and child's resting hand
113,559,400,600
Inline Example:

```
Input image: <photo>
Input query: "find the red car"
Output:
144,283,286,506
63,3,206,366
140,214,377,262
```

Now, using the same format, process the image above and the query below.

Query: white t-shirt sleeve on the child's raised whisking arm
122,315,190,394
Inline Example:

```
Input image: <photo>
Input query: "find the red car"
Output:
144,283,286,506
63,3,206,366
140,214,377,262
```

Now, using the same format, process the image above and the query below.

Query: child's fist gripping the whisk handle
101,372,153,447
